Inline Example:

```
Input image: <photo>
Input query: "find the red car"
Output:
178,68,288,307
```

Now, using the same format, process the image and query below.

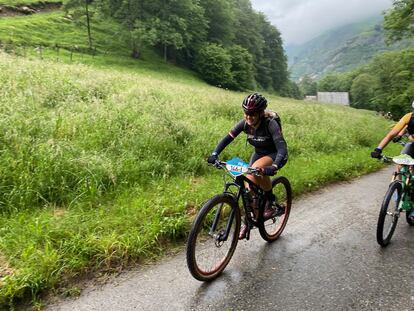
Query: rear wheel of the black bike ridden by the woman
259,176,292,242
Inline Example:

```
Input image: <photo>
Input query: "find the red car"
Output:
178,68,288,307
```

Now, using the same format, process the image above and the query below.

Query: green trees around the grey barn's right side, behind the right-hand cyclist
318,48,414,119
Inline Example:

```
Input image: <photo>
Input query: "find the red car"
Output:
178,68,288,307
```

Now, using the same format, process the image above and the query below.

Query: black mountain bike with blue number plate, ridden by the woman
187,158,292,281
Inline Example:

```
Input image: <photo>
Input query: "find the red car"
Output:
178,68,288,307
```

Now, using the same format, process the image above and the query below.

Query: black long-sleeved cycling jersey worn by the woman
215,118,288,168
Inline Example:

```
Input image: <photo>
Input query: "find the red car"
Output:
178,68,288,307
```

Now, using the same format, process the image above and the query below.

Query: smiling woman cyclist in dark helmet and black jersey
207,93,288,239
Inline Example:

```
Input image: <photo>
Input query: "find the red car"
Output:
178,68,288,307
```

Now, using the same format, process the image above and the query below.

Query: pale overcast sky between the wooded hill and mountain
250,0,392,45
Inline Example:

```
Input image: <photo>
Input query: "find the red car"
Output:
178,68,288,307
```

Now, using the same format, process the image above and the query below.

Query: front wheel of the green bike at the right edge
377,180,402,247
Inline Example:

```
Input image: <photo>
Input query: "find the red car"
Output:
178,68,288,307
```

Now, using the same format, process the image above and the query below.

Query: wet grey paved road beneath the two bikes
46,167,414,310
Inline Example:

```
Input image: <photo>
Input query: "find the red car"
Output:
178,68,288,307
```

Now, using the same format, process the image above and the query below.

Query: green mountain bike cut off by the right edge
377,154,414,247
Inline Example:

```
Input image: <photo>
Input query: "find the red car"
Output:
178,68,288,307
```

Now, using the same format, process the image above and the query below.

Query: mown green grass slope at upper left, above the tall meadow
0,11,200,83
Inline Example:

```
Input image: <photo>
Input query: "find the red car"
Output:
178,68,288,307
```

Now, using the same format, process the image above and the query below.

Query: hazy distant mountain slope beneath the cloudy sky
286,16,409,80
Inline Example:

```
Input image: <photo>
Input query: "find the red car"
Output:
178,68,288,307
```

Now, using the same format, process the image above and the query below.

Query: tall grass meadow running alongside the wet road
0,54,398,305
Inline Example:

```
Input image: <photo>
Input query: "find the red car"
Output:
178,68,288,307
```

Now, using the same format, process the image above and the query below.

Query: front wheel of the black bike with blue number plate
187,194,241,281
